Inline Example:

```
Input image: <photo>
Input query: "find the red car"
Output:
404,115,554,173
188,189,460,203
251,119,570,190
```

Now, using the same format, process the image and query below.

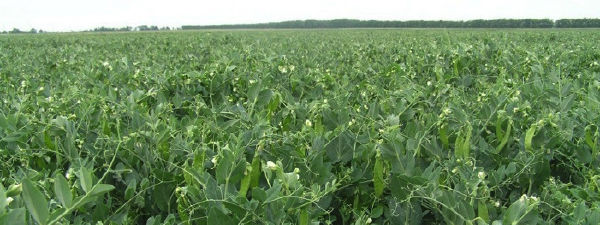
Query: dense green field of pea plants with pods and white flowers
0,30,600,225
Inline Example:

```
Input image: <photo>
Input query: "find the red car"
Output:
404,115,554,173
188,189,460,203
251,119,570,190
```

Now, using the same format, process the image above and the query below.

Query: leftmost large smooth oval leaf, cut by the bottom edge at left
22,179,48,225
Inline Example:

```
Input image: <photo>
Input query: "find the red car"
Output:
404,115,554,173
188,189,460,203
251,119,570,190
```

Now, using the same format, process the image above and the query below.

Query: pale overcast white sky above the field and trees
0,0,600,31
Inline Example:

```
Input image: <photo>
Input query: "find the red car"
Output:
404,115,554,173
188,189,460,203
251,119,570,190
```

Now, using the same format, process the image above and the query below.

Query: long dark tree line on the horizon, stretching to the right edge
181,19,600,30
